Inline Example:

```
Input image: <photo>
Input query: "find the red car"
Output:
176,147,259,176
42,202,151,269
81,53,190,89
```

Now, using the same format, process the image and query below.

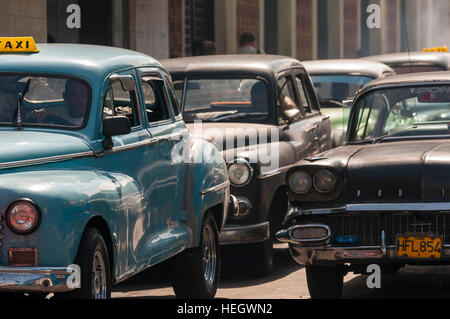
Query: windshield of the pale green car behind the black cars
311,75,373,107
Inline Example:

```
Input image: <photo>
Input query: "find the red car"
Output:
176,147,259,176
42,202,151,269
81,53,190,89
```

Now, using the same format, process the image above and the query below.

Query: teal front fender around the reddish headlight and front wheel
0,169,142,268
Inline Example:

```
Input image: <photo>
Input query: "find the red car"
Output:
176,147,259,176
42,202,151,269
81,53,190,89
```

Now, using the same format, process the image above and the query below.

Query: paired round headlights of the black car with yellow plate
289,169,337,194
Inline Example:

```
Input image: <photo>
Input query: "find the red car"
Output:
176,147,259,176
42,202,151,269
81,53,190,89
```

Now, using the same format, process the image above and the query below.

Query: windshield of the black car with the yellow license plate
349,85,450,141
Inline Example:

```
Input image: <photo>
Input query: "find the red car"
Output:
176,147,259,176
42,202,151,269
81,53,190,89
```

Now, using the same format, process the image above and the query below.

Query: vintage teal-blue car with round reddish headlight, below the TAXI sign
0,40,230,298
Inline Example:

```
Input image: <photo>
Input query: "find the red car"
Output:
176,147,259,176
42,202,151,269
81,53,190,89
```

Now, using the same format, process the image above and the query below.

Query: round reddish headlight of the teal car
6,200,39,235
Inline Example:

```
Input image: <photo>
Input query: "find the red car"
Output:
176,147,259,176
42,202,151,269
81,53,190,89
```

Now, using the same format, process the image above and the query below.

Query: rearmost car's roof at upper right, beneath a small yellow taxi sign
362,51,450,74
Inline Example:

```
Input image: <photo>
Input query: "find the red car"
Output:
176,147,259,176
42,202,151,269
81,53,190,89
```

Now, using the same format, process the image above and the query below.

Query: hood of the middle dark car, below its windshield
186,122,278,151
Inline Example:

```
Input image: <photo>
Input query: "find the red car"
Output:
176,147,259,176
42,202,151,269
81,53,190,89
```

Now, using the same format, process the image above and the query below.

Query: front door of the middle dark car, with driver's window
277,70,319,161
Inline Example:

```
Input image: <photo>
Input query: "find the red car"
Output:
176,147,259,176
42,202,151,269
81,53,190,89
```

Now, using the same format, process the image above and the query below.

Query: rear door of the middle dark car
293,69,331,152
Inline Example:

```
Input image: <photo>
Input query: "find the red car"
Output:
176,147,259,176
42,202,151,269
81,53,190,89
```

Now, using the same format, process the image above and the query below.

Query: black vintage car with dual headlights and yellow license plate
276,71,450,298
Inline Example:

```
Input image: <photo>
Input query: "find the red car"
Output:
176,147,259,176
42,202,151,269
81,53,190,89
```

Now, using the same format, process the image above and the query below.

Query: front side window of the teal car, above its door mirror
103,81,140,127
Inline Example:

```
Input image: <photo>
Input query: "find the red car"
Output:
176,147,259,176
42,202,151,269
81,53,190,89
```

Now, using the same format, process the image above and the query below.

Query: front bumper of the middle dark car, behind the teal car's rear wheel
219,222,270,245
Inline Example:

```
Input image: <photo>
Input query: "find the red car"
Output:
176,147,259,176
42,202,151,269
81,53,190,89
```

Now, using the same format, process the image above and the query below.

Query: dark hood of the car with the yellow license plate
347,140,450,202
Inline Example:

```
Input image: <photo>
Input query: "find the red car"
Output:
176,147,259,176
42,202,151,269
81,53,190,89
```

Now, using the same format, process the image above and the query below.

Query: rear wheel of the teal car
172,213,221,299
